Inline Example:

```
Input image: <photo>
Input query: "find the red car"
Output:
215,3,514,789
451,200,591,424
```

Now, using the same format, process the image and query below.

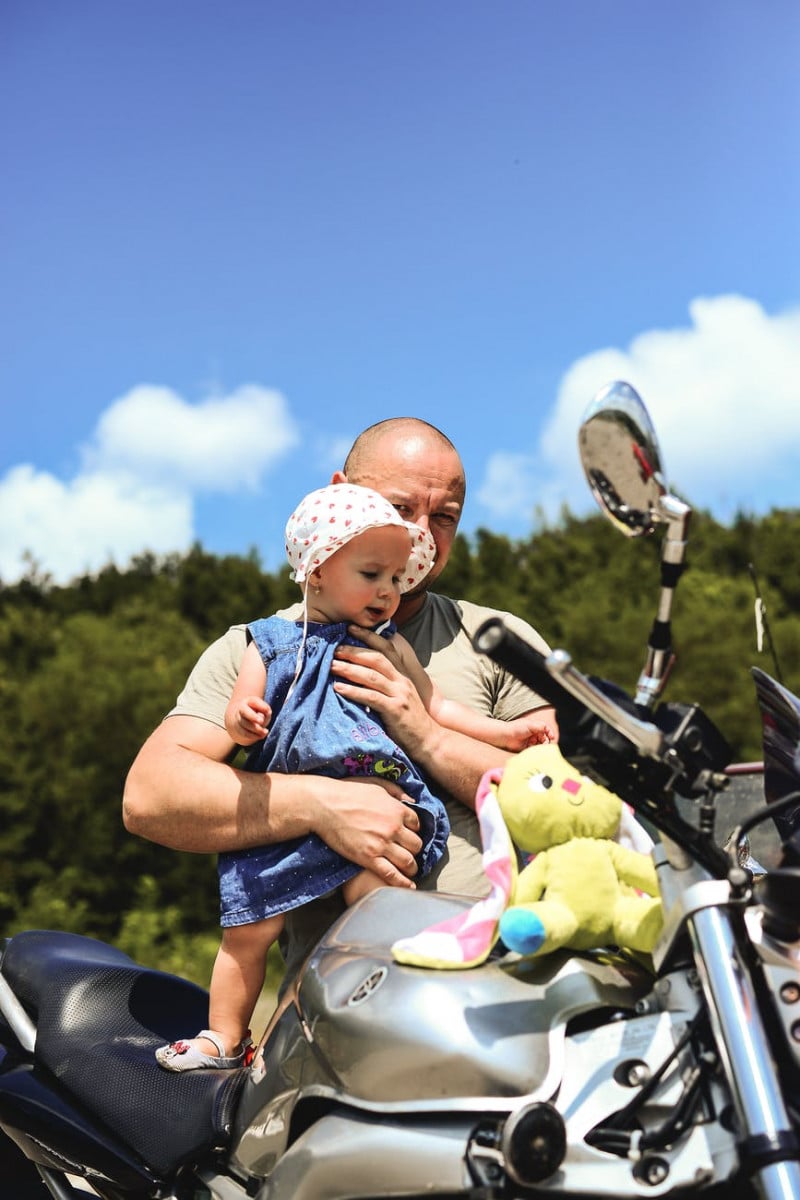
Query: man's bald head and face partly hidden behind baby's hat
333,433,464,595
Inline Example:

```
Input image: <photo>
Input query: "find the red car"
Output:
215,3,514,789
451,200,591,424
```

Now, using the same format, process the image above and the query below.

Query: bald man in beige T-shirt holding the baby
124,418,555,973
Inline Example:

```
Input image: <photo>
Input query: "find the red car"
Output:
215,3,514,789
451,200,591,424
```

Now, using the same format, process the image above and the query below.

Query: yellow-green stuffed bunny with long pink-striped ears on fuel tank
392,743,663,970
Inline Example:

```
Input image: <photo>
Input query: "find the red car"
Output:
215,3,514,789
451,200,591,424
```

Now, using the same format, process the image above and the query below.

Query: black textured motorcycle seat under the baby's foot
0,930,245,1178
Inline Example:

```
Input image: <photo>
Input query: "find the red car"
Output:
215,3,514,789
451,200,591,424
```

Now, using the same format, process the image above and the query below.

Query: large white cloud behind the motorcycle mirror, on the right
479,295,800,520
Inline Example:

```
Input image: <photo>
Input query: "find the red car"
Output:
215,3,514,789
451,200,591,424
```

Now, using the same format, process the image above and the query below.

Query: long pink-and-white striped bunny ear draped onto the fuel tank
392,768,517,971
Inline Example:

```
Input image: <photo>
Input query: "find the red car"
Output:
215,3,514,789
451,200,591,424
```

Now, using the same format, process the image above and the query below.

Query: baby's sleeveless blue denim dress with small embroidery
218,617,450,926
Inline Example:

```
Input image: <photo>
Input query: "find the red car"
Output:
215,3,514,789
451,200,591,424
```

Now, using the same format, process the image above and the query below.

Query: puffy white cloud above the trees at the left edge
0,384,297,583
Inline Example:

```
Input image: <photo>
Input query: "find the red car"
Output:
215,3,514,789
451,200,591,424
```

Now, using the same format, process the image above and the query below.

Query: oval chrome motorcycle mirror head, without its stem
578,379,667,538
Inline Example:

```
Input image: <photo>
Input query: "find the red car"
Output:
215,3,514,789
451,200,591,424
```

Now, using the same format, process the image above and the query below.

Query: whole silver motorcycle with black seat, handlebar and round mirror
0,383,800,1200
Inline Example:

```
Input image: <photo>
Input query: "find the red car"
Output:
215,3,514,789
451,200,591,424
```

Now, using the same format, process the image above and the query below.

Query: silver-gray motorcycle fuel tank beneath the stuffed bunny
297,888,652,1103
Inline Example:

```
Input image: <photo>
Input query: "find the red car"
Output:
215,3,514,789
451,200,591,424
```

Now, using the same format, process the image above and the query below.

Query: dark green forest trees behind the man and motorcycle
0,510,800,980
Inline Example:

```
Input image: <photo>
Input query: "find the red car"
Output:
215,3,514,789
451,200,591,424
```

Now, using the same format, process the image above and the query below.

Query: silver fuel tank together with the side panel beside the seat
234,888,652,1175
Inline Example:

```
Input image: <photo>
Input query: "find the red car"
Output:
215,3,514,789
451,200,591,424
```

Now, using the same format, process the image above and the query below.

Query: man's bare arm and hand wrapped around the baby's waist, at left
122,716,421,887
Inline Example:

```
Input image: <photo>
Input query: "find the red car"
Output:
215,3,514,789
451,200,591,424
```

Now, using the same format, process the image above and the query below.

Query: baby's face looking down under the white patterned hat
308,526,411,628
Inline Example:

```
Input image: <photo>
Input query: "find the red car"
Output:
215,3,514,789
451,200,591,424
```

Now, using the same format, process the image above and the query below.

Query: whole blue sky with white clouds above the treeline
0,0,800,582
